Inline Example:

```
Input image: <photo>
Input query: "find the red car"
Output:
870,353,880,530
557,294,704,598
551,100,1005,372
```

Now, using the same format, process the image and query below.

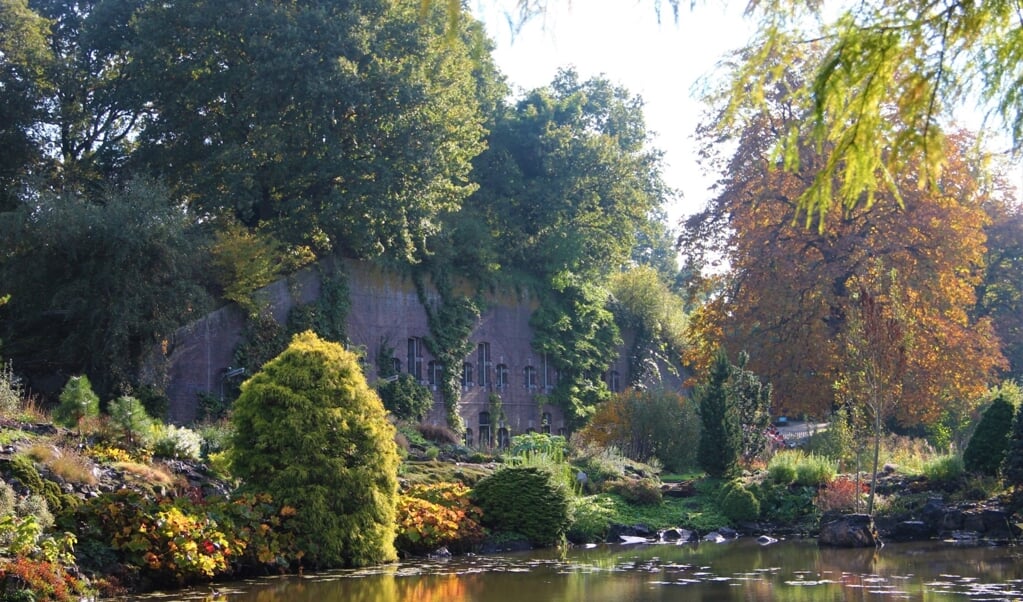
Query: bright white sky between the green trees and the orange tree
471,0,754,225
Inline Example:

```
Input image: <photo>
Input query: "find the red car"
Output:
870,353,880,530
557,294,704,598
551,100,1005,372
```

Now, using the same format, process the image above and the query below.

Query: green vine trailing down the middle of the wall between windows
413,271,484,434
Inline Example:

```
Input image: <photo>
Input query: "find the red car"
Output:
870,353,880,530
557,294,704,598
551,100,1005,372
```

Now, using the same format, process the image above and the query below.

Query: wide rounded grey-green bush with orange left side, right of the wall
578,389,700,472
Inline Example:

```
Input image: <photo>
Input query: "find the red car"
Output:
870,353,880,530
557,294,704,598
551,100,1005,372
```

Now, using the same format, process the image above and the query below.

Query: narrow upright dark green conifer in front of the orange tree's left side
694,349,743,478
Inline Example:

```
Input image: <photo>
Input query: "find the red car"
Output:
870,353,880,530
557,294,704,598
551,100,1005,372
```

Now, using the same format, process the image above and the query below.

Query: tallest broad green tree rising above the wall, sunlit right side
129,0,487,259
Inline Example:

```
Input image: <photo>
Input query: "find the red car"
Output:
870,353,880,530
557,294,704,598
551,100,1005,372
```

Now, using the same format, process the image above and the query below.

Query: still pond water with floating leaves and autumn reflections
148,539,1023,602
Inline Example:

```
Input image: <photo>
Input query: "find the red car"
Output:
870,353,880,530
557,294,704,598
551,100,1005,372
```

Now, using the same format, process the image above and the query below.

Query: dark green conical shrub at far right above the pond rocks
963,381,1023,476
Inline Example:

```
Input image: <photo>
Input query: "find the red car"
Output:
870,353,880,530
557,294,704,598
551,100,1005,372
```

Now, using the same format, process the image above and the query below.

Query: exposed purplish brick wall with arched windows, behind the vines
165,255,627,445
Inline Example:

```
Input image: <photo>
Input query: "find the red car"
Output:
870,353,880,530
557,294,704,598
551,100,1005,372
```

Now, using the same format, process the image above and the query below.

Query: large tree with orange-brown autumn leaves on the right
679,63,1004,425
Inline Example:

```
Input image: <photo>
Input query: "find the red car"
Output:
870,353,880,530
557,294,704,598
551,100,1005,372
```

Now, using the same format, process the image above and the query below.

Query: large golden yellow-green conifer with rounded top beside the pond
232,331,399,567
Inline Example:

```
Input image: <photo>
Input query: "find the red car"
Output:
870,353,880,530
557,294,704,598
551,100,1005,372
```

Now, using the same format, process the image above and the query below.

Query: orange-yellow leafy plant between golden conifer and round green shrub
395,483,484,554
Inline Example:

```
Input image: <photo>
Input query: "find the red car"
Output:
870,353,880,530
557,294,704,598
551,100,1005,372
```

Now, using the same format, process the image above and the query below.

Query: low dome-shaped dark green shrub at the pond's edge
473,466,571,546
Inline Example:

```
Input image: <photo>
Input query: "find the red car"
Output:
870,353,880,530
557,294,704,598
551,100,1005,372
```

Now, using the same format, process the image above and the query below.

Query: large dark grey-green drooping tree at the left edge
0,179,210,397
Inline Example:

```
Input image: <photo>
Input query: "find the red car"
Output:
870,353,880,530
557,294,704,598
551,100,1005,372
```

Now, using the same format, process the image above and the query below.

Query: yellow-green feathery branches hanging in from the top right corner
721,0,1023,221
